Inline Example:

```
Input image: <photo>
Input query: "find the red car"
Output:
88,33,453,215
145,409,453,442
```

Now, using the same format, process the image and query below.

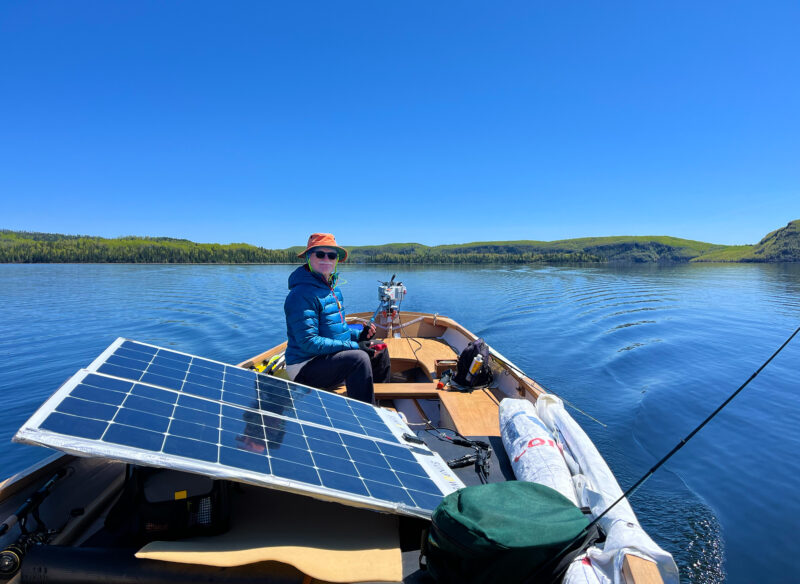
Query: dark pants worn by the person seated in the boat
294,349,391,404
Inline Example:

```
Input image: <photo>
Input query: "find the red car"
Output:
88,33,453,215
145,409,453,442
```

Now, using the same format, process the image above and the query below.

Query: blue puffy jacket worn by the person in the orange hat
283,266,358,365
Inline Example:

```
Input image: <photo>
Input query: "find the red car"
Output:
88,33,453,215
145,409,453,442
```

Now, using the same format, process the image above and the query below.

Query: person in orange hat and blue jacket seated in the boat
283,233,391,403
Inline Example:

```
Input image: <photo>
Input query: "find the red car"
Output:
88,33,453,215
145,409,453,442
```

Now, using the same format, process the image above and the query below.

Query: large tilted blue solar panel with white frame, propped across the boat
15,339,463,517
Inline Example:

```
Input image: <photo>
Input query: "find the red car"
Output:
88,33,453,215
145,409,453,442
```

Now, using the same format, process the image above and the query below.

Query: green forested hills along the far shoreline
0,220,800,264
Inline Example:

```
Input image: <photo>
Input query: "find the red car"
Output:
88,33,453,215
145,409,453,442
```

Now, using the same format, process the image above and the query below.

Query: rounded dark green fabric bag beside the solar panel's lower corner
423,481,589,584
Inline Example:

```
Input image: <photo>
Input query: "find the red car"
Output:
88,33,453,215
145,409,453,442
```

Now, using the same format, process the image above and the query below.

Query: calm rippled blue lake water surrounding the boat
0,265,800,583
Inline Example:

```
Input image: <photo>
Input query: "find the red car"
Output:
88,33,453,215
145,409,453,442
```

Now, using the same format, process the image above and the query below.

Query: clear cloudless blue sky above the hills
0,0,800,248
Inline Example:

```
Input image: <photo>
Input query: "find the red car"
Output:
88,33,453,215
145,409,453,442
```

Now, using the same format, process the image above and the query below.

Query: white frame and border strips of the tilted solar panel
14,338,464,518
